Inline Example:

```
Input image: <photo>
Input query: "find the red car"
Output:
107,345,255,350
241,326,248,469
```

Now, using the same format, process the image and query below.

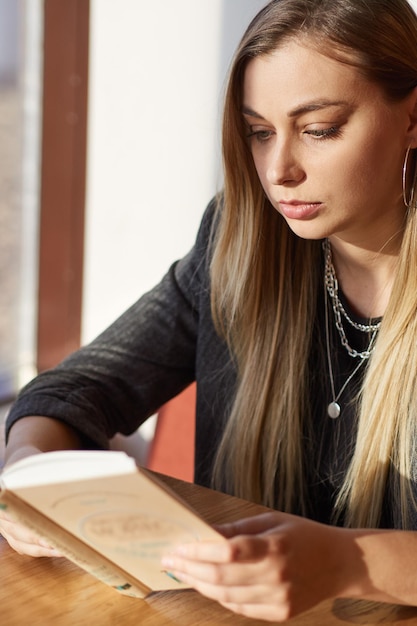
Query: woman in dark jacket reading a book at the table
0,0,417,621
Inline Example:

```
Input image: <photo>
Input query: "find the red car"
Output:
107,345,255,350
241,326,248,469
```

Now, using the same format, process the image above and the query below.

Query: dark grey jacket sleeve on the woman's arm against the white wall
6,200,213,448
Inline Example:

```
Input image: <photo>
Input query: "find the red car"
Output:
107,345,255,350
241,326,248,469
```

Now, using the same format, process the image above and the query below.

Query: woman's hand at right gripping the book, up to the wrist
163,512,363,621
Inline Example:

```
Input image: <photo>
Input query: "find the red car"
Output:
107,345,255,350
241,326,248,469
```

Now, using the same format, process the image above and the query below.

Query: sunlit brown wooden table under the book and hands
0,477,417,626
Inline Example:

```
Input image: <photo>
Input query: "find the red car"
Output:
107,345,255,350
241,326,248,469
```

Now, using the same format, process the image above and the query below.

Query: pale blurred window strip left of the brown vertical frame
0,0,42,402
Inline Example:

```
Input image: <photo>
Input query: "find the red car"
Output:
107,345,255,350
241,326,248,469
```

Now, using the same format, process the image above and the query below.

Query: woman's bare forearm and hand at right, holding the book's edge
163,513,417,621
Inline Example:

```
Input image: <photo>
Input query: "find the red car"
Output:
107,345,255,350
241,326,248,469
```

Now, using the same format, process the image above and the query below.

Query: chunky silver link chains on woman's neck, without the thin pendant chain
323,239,381,359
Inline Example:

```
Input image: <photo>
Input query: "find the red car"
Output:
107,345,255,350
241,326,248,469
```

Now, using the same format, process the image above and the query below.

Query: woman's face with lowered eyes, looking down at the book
243,41,416,249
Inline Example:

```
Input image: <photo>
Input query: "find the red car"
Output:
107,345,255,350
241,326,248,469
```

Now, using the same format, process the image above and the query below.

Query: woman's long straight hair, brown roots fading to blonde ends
211,0,417,527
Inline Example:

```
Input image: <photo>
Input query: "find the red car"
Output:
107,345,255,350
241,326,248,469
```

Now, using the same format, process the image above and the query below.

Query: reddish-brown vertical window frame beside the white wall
36,0,90,371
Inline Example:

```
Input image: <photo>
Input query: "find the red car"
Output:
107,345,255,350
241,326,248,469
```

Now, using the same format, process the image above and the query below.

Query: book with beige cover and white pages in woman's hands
0,451,222,598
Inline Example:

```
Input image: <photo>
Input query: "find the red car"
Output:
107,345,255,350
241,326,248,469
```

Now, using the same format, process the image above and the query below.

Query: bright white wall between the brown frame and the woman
83,0,265,342
